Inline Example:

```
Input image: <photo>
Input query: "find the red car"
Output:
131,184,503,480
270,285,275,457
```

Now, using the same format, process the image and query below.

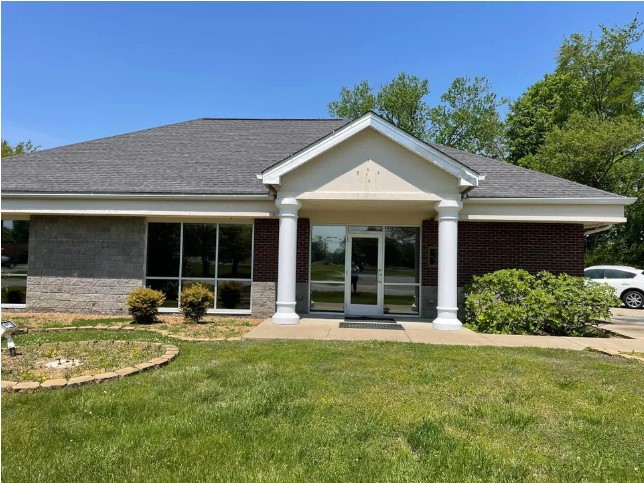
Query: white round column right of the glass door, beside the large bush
434,200,463,330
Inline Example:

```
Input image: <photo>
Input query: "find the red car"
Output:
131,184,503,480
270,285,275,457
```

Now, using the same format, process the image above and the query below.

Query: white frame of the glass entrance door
344,231,385,316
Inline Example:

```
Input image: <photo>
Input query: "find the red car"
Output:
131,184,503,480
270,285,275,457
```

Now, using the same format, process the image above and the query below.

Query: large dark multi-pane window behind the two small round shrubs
146,223,253,311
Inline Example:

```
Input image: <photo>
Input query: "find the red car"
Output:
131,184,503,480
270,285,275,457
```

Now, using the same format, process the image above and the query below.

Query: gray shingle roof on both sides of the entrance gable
2,119,618,198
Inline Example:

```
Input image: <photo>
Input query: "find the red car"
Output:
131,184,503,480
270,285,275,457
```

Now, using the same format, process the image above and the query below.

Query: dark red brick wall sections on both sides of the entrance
260,218,584,287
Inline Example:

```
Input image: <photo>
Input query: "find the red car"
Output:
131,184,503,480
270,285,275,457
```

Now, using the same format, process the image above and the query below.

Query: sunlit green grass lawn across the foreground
2,331,644,482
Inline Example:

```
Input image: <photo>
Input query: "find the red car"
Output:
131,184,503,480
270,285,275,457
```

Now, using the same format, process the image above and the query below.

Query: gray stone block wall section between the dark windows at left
27,216,145,314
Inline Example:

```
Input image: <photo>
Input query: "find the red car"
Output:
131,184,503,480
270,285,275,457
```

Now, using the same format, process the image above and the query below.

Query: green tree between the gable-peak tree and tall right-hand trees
428,77,507,158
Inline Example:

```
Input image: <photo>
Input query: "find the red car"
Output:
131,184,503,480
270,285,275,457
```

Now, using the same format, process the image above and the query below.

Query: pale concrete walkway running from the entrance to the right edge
244,316,644,352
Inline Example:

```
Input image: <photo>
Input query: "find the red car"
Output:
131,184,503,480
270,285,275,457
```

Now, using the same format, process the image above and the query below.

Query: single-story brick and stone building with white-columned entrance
2,113,633,329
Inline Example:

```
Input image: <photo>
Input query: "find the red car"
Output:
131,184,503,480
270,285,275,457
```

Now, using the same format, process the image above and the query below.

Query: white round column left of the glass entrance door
273,198,301,324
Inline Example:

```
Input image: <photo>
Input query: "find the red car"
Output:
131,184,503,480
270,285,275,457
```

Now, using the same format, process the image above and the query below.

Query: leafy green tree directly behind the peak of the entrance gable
327,72,429,139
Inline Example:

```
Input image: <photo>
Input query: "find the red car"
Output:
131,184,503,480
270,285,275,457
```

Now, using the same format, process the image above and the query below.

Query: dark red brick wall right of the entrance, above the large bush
422,220,584,286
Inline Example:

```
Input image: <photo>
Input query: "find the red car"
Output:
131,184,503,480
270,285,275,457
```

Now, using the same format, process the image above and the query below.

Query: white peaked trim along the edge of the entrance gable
257,112,483,187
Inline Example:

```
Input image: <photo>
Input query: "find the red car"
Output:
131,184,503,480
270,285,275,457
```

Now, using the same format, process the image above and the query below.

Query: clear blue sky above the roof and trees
1,2,642,148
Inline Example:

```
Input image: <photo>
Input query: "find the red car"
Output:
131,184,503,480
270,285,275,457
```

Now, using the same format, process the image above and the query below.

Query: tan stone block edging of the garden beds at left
1,340,179,392
